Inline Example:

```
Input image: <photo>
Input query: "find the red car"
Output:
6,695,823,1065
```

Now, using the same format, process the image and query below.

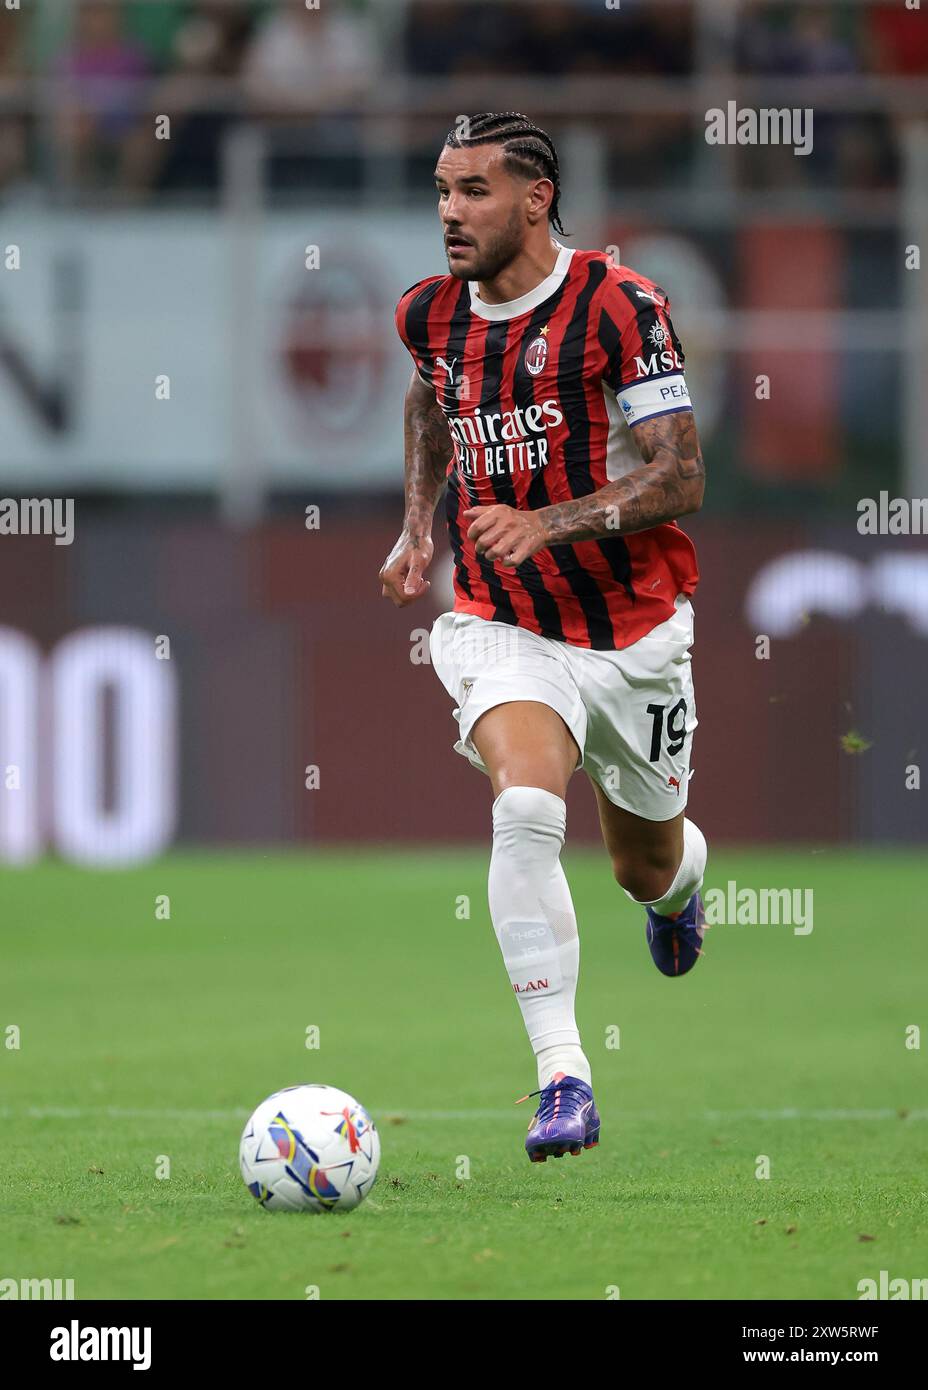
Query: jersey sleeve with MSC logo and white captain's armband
599,267,692,425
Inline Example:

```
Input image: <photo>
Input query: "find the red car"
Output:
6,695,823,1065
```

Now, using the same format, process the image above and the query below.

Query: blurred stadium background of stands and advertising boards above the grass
0,0,928,866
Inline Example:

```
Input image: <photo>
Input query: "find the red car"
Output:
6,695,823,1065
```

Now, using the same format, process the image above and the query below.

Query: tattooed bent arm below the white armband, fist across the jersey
464,410,704,566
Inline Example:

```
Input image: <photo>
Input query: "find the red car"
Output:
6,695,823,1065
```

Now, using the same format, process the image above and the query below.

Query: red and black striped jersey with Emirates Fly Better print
396,247,699,651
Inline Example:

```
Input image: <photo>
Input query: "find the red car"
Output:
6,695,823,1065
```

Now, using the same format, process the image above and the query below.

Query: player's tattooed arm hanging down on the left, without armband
379,371,451,607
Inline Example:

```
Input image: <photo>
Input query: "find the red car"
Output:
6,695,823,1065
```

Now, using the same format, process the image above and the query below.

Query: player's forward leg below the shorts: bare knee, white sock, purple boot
470,699,600,1162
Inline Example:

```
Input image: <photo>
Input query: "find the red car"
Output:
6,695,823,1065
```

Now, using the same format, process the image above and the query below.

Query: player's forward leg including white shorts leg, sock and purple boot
429,613,599,1161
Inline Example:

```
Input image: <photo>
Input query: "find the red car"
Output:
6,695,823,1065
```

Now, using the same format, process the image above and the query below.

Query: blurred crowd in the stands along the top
0,0,928,200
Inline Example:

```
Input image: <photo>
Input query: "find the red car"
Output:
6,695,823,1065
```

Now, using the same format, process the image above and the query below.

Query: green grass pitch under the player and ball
0,847,928,1300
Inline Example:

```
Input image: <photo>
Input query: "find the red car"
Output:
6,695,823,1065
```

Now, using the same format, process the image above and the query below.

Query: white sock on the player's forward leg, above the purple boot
488,787,590,1088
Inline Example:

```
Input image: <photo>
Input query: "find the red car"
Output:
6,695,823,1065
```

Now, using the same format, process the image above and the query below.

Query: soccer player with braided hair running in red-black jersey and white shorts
381,111,706,1162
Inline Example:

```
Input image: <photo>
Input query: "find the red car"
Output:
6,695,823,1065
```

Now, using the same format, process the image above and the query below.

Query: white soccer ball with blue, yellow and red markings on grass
239,1086,381,1212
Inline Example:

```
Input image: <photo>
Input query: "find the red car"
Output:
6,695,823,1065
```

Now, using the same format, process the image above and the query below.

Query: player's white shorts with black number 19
429,594,696,820
